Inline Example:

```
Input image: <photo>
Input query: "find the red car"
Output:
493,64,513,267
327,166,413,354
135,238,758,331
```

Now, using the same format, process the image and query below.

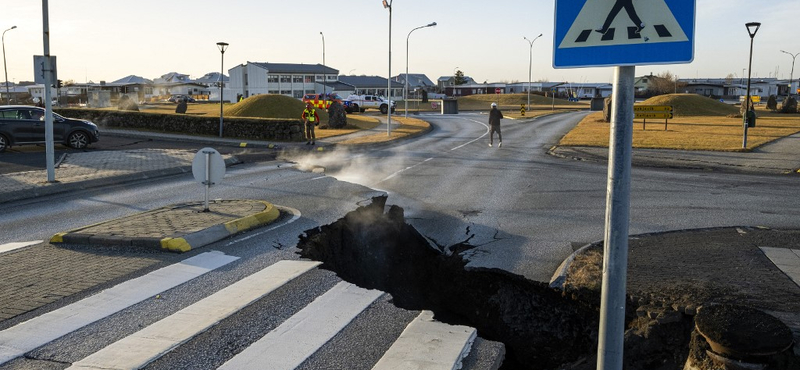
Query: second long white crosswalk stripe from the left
70,260,321,369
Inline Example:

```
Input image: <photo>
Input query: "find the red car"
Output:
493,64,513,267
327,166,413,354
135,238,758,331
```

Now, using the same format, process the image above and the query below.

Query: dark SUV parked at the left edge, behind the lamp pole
0,105,99,152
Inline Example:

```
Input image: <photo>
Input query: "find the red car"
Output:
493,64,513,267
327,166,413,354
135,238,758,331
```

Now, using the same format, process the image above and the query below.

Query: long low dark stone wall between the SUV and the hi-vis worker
54,108,305,141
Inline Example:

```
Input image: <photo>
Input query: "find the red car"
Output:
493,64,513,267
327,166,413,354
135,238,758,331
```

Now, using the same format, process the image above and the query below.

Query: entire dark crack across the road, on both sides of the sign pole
298,196,724,370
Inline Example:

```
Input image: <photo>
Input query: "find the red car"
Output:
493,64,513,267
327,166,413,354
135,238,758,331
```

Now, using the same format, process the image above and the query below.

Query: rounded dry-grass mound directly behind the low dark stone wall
225,94,305,119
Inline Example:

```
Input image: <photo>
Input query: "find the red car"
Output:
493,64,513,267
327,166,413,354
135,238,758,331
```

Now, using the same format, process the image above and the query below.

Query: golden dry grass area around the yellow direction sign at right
558,109,800,151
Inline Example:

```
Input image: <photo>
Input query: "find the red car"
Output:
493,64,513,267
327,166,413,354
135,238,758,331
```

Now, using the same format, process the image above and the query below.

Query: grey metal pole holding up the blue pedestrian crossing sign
597,66,636,370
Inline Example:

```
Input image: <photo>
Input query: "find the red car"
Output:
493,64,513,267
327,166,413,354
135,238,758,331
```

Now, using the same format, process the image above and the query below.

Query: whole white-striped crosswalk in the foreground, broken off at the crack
0,251,504,370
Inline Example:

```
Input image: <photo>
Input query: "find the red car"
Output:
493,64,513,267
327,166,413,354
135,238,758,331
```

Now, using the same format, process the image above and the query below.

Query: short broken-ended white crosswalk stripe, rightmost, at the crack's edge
372,311,477,370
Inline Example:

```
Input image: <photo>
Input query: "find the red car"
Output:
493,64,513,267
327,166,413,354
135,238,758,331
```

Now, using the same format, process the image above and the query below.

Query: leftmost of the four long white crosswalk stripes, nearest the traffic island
0,251,239,364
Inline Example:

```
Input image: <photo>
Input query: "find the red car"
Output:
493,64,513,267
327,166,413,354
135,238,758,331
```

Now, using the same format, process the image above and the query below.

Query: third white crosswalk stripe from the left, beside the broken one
219,282,383,370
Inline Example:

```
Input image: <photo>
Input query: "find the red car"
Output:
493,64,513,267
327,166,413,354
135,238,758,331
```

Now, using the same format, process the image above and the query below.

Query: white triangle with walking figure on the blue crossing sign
558,0,689,49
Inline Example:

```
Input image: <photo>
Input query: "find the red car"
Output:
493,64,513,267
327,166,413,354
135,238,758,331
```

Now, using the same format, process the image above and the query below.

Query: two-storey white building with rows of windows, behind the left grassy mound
228,62,339,99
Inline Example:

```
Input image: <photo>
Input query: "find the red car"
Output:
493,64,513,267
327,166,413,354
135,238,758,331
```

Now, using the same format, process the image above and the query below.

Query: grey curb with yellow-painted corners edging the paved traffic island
50,200,280,253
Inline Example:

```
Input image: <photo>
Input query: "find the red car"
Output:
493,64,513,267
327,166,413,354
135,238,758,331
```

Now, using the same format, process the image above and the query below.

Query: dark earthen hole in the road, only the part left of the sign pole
298,197,598,369
